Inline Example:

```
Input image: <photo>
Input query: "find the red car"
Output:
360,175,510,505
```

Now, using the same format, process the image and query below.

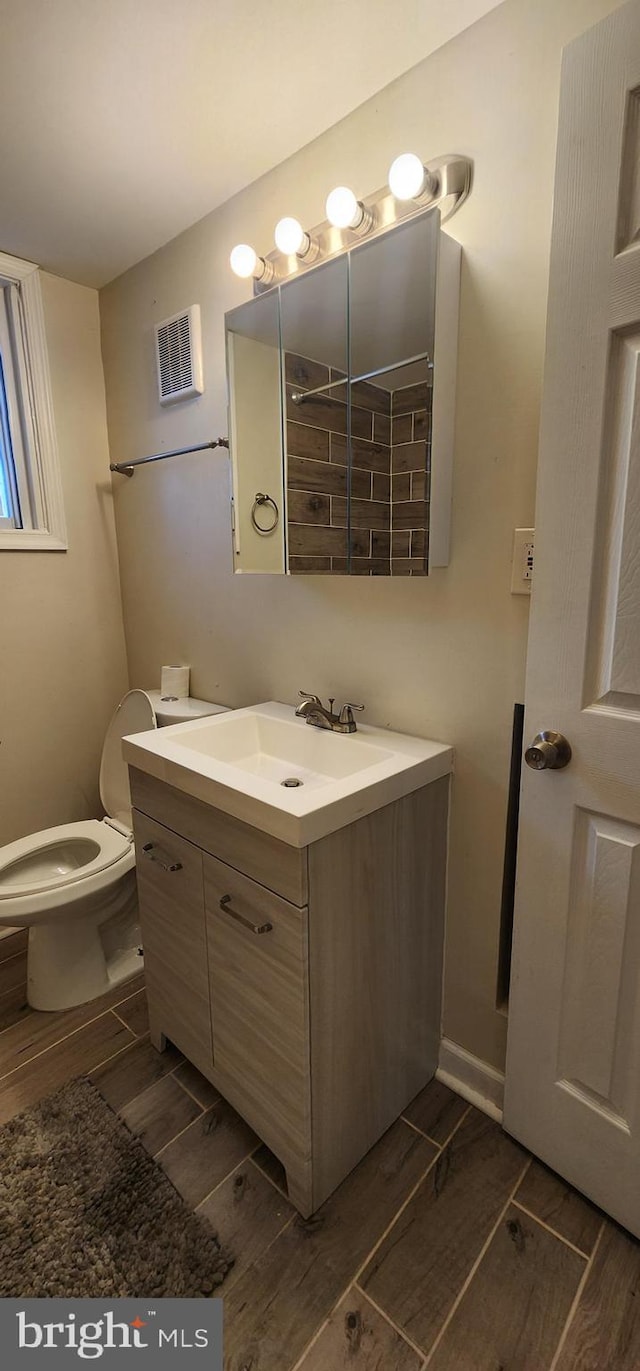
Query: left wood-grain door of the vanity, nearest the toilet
133,810,212,1072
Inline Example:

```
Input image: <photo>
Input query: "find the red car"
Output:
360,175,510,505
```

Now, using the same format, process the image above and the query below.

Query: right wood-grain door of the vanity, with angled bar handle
204,856,311,1165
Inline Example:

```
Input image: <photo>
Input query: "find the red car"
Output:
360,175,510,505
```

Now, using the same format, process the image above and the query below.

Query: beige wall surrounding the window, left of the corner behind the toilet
0,276,126,845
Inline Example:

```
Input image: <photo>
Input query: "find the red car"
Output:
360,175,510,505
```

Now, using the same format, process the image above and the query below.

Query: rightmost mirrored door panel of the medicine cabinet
349,213,440,576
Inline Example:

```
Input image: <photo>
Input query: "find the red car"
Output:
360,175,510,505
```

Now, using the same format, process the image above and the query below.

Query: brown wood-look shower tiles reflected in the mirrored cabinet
285,352,430,576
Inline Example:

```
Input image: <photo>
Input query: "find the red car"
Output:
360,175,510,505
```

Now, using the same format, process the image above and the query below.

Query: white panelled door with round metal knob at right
504,0,640,1235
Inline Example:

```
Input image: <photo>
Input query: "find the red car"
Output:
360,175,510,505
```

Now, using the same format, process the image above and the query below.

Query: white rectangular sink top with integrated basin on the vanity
123,701,454,847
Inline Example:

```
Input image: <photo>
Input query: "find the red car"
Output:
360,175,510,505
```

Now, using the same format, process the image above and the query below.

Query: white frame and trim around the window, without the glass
0,252,67,553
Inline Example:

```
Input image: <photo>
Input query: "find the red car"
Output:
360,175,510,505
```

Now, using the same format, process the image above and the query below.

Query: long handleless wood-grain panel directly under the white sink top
129,766,308,905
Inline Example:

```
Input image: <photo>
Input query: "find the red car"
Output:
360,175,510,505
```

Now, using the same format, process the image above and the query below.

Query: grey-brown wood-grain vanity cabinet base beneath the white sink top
130,768,450,1216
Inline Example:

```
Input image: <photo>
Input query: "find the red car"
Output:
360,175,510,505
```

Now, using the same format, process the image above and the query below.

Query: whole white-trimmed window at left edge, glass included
0,252,67,551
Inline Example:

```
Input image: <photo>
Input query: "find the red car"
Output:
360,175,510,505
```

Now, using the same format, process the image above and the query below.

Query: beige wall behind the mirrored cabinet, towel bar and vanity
100,0,627,1067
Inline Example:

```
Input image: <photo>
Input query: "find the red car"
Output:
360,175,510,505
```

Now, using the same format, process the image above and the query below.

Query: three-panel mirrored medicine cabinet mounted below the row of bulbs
226,210,459,576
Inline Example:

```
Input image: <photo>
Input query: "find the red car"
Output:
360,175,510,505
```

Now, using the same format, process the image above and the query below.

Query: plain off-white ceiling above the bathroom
0,0,496,287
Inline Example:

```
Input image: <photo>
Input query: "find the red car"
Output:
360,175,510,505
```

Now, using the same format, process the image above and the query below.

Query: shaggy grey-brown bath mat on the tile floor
0,1080,232,1298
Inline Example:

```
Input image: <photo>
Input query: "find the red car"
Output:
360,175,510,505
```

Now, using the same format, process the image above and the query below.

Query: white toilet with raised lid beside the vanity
0,690,226,1010
